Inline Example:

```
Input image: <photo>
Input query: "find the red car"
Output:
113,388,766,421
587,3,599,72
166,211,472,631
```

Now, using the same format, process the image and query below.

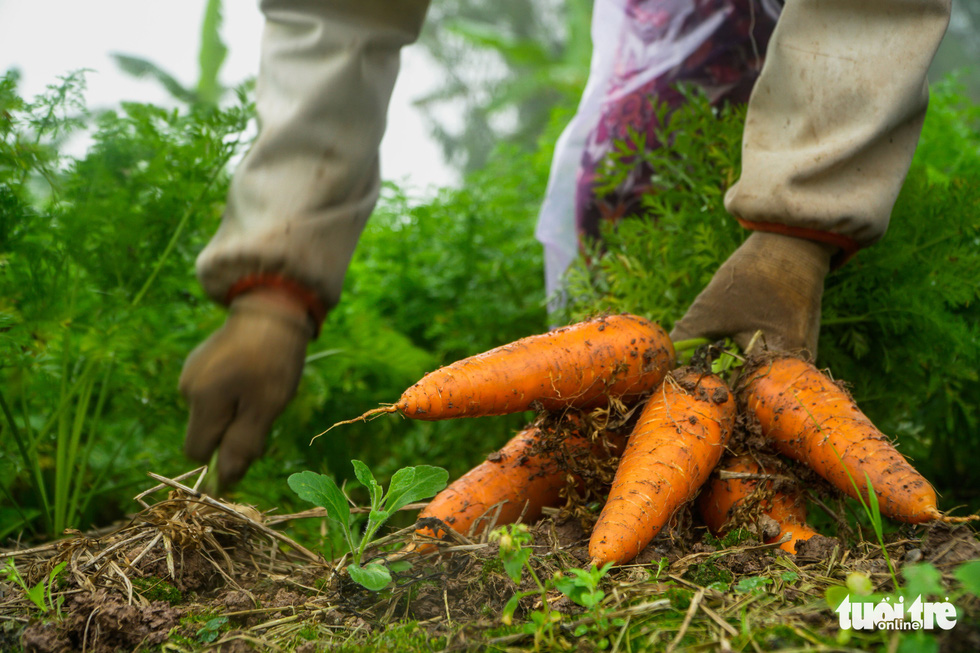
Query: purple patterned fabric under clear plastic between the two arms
575,0,778,240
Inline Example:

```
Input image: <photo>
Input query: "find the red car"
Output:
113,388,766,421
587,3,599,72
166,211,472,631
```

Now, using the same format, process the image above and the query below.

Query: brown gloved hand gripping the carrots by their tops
670,231,836,358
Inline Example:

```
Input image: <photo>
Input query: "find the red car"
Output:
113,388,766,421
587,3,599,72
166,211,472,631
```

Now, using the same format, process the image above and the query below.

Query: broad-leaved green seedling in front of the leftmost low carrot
288,460,449,592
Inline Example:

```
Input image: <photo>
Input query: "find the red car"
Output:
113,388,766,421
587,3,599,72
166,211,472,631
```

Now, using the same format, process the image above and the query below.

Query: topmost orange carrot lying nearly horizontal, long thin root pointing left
331,314,675,428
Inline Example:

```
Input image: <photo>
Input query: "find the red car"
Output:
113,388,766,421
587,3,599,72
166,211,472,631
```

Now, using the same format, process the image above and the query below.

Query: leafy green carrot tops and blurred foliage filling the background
0,0,980,539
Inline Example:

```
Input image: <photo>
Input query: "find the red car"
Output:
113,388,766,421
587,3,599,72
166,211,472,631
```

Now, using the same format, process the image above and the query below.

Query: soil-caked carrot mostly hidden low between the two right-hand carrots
697,456,817,553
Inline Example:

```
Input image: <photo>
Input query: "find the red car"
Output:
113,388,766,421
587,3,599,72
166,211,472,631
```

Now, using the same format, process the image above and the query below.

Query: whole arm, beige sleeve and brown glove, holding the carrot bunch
671,0,951,355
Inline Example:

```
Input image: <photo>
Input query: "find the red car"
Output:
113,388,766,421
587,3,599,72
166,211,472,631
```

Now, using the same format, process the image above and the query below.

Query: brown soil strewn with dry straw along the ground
0,472,980,653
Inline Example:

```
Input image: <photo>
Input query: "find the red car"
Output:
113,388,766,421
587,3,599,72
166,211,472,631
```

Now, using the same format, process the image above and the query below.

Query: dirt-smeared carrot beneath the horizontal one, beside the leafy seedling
417,423,625,538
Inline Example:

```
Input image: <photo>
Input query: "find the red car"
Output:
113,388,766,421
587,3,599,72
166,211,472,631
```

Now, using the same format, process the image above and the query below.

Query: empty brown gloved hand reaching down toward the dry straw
180,289,313,487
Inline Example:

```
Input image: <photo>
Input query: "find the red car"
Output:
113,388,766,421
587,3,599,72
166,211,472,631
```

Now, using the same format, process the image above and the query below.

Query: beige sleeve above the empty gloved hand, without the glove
197,0,428,306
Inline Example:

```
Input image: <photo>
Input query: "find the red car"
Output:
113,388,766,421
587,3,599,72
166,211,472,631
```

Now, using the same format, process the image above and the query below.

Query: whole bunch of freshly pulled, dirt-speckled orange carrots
326,314,968,565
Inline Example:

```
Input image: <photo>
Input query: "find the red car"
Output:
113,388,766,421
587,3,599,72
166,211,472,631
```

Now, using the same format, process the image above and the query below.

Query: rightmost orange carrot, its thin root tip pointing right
739,357,970,524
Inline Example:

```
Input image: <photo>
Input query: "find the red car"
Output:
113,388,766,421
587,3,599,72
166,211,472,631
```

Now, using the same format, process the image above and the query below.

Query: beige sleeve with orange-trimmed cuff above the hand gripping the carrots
725,0,951,252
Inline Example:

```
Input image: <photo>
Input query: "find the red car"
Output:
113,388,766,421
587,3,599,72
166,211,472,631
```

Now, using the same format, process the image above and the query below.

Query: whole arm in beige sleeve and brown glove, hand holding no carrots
180,0,428,485
